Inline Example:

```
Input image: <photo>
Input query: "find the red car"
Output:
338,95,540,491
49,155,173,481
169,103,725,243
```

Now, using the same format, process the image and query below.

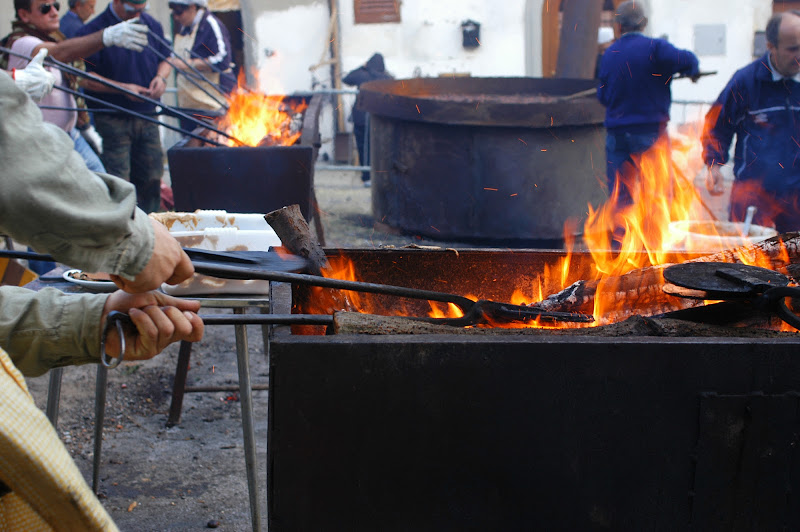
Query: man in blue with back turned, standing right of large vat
597,1,699,212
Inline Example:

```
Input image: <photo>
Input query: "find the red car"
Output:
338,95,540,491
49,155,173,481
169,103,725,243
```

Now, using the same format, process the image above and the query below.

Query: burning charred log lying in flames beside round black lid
533,233,800,323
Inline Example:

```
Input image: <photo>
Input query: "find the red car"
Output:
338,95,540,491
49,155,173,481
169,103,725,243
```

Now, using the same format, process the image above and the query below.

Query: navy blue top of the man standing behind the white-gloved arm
77,4,170,113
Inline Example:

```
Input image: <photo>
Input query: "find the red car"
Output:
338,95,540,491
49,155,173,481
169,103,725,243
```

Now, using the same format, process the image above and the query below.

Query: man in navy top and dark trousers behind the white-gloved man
78,0,172,212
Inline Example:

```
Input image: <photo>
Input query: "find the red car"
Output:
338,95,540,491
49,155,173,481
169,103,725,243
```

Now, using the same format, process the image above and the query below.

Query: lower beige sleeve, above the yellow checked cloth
0,286,108,377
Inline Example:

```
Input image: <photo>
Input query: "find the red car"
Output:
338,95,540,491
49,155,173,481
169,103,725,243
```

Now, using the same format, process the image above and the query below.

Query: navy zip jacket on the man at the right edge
703,55,800,192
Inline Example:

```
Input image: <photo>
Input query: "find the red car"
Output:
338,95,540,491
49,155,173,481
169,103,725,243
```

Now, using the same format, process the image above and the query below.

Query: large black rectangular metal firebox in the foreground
268,250,800,530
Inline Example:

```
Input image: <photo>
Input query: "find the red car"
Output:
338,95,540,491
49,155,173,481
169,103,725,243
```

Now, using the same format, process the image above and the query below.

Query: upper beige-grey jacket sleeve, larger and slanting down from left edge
0,71,154,279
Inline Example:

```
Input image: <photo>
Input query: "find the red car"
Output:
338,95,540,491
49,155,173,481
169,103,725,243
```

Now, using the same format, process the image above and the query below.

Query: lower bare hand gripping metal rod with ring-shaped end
101,291,204,360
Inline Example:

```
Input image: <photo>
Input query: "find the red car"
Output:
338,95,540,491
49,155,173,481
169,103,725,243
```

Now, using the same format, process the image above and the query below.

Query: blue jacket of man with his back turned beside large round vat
597,33,699,129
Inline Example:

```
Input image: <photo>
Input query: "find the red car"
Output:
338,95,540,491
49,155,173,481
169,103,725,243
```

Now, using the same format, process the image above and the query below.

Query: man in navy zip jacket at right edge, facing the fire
703,12,800,233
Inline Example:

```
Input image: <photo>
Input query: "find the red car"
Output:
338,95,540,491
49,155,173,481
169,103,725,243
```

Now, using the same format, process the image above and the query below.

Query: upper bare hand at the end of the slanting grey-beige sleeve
111,219,194,294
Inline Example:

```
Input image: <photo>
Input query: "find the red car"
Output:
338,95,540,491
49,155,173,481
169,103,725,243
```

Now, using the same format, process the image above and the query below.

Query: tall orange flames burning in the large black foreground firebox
296,119,788,328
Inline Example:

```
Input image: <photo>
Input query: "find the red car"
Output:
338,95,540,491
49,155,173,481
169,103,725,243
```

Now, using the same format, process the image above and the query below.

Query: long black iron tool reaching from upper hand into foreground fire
186,249,594,327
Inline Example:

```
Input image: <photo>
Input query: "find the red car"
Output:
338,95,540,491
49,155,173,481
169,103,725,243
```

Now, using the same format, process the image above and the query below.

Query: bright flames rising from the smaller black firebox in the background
220,75,308,146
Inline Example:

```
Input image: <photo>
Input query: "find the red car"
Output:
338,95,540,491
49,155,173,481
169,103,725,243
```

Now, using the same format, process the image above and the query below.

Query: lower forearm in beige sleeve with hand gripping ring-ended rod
0,286,203,377
